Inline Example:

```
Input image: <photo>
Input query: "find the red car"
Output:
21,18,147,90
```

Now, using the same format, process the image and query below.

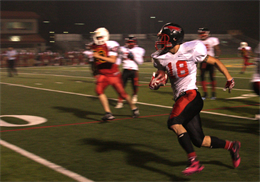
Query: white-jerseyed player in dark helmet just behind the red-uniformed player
115,35,145,108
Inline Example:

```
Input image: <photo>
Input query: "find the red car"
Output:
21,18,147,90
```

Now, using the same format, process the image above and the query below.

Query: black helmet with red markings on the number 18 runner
155,23,184,52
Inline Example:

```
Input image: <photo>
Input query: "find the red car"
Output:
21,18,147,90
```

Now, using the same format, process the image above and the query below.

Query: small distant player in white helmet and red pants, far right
238,42,254,74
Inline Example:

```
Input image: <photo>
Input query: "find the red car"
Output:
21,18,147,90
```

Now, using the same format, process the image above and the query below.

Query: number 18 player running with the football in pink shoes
149,23,240,175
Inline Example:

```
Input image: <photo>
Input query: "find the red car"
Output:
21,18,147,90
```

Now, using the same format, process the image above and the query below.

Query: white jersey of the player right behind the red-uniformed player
116,46,145,70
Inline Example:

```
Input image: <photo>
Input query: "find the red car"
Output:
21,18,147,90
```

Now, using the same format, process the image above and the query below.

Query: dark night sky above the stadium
0,0,260,40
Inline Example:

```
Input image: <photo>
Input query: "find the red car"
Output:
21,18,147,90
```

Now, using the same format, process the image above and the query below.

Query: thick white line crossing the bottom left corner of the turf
0,139,93,182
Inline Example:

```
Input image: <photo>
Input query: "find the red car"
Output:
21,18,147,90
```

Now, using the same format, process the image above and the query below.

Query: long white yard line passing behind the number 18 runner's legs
0,82,255,120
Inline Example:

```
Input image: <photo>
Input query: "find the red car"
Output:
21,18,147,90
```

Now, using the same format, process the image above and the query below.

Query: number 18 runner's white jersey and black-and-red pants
152,40,207,146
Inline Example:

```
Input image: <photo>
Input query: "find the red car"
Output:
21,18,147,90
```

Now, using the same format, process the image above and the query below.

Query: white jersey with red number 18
152,40,207,99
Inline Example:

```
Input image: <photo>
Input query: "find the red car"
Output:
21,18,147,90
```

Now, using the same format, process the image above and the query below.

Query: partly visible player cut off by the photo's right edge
251,42,260,120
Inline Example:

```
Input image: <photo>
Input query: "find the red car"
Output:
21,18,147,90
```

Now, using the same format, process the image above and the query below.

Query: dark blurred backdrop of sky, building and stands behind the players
0,0,260,63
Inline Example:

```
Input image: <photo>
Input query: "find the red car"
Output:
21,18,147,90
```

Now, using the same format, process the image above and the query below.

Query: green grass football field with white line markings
0,59,260,182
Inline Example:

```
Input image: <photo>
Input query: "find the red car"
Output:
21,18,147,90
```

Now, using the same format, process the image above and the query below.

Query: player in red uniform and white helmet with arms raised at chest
85,27,139,121
